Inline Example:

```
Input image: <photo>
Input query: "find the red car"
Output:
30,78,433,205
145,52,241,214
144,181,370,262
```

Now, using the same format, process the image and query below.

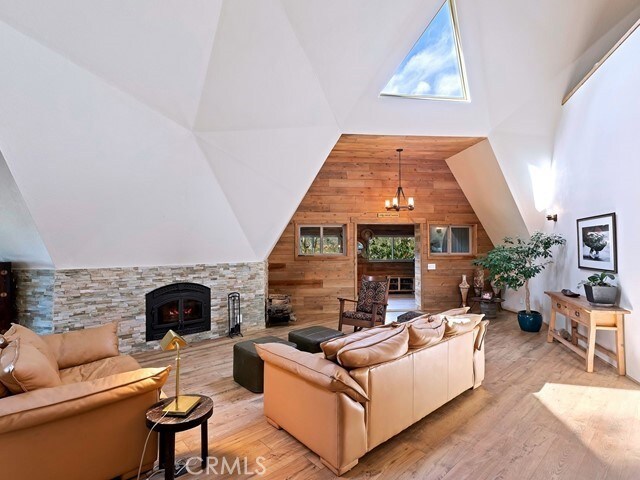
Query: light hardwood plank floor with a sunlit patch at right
137,313,640,480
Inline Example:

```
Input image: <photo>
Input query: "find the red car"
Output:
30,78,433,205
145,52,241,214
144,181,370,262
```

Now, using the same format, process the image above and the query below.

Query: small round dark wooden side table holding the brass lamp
147,395,213,480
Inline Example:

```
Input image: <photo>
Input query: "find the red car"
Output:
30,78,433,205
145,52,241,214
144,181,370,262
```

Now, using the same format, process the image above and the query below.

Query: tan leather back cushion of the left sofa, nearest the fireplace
42,322,119,368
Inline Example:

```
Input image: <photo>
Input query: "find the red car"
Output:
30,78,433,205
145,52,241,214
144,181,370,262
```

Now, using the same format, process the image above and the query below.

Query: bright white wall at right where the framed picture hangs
533,26,640,380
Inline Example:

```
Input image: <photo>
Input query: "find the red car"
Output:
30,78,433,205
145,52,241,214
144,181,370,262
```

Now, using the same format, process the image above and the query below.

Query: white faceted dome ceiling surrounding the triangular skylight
0,0,638,268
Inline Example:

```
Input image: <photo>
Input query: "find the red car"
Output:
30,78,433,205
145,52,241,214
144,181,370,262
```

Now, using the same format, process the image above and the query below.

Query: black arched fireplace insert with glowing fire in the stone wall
146,283,211,341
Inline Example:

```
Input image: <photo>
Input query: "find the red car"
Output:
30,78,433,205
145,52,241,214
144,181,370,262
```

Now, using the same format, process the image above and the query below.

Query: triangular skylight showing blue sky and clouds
380,0,468,100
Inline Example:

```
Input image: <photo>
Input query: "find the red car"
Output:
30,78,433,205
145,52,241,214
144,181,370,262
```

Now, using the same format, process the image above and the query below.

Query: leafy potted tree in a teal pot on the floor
473,232,566,332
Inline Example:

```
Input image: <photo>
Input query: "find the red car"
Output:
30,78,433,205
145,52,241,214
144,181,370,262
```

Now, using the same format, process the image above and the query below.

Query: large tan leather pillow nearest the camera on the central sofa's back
337,324,409,368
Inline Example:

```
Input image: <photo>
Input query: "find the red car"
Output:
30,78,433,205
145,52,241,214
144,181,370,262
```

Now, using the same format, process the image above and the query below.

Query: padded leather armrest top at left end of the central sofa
256,343,369,402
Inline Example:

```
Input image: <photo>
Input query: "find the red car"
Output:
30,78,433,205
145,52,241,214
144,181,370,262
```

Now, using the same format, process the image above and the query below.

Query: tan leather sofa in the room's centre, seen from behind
256,320,488,475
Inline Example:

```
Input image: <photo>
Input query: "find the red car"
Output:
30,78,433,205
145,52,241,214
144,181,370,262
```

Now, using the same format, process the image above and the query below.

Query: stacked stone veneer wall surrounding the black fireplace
16,262,267,353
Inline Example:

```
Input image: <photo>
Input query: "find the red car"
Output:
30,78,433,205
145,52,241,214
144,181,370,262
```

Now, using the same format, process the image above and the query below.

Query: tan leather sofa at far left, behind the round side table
0,324,169,480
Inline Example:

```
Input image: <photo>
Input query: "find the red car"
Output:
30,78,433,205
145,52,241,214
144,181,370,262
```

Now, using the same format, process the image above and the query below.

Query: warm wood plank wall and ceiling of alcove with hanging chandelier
269,135,493,323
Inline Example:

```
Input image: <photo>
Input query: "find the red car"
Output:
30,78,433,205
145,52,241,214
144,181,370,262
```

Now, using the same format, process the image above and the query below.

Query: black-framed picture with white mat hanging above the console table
577,213,618,273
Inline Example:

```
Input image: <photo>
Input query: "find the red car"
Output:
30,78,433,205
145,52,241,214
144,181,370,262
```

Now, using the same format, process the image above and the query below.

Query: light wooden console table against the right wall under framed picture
544,292,631,375
